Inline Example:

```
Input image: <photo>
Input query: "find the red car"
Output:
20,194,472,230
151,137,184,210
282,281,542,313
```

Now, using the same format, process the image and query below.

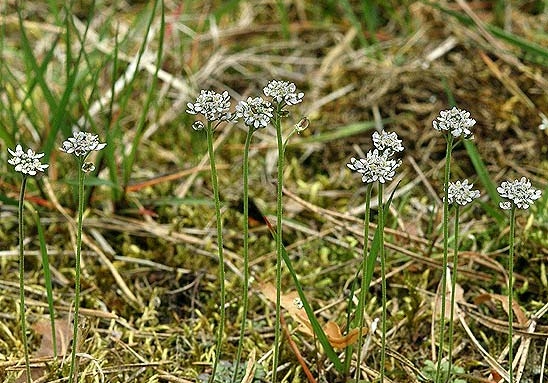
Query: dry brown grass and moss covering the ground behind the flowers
0,0,548,382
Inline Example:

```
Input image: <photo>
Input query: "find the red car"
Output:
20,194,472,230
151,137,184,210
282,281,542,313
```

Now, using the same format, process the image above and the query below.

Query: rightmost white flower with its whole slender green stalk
497,177,542,383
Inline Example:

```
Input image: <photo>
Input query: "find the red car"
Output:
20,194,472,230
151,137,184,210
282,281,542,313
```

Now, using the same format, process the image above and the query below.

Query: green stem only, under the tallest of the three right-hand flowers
436,133,453,383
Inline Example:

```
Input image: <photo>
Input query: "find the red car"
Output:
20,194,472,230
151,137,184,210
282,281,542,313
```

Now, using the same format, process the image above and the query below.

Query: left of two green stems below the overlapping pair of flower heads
356,183,373,382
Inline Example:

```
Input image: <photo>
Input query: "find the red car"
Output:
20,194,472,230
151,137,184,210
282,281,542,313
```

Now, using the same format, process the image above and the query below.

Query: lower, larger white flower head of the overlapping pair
346,149,401,184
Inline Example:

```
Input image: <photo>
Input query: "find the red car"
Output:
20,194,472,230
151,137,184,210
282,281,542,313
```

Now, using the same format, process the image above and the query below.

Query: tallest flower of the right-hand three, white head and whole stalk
432,107,476,382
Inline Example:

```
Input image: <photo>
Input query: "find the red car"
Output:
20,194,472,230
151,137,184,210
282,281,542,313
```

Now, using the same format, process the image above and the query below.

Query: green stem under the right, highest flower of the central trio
272,104,284,383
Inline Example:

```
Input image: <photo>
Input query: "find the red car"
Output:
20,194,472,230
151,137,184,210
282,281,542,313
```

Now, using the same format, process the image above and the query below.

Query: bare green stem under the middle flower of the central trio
232,128,254,383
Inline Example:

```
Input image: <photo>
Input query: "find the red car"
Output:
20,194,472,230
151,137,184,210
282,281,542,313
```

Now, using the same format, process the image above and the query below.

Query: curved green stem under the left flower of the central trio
206,121,226,383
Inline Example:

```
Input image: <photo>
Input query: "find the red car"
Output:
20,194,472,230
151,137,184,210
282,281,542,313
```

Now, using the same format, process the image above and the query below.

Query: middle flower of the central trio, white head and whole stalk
232,97,273,383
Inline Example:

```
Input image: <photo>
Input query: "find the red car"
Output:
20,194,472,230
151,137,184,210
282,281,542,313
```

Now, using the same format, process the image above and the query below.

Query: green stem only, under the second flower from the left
69,157,84,383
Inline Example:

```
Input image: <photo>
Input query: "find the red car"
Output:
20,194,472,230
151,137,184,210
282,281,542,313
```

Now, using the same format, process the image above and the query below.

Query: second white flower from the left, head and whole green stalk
60,132,107,383
